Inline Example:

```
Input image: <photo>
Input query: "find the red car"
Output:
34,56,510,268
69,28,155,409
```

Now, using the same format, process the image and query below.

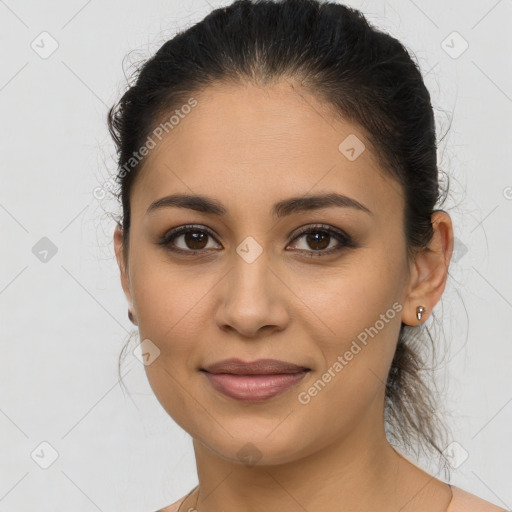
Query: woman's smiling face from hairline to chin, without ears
116,82,424,464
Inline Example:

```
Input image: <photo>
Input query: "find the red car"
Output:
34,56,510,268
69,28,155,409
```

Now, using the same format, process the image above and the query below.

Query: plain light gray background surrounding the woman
0,0,512,512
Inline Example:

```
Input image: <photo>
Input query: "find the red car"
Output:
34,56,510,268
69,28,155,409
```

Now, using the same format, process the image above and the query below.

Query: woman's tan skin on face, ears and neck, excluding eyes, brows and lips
114,80,453,512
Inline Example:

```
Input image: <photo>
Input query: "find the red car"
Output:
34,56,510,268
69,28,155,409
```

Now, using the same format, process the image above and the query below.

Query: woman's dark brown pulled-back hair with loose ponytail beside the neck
108,0,447,471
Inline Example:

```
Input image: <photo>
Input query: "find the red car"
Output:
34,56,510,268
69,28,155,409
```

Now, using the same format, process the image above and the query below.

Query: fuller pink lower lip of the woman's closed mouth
203,371,307,402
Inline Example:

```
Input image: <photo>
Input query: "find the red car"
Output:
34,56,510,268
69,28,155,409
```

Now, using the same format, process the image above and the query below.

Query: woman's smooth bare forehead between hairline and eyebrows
131,82,402,221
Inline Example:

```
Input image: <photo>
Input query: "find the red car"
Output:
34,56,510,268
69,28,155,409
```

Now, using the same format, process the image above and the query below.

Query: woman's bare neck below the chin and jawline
190,414,419,512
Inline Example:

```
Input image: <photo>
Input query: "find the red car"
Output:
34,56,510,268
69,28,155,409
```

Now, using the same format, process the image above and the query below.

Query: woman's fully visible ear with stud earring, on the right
402,210,453,325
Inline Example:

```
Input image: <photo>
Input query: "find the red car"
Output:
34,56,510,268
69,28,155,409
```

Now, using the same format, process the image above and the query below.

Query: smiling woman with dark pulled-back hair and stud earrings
109,0,503,512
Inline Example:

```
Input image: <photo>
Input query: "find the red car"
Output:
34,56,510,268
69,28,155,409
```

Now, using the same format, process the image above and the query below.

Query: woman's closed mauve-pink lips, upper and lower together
200,359,310,402
